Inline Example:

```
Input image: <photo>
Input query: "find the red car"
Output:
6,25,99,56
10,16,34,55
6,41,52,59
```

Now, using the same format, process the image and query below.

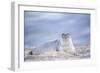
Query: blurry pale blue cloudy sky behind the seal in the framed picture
24,11,90,48
